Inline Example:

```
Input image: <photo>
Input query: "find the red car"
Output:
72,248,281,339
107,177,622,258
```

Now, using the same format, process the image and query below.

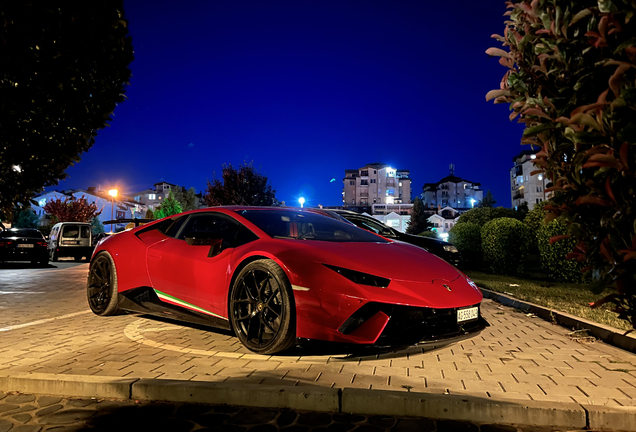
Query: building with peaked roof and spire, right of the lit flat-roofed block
422,171,484,208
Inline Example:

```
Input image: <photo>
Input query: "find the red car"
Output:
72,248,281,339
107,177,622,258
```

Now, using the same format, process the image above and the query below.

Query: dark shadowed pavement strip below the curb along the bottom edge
0,392,608,432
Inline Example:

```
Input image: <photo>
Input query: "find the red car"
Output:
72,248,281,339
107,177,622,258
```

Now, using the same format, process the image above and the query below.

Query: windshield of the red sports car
236,210,388,243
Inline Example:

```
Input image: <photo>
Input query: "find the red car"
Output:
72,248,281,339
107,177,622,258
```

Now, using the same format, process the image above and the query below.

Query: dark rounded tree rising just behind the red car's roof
203,164,276,207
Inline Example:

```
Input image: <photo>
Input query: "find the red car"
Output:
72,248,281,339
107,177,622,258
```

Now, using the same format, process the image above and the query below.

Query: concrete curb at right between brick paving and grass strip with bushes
481,288,636,353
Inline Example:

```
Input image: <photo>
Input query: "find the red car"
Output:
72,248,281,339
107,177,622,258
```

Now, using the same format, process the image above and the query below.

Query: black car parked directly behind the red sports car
308,209,461,267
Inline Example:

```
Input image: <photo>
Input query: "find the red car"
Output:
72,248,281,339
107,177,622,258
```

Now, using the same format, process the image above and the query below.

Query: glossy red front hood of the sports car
280,240,460,283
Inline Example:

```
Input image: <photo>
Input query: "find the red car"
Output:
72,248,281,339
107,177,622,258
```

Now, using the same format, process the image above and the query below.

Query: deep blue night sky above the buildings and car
47,0,523,207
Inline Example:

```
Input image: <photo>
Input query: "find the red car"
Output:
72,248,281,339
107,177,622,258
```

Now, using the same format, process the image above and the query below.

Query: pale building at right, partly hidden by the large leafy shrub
510,149,549,210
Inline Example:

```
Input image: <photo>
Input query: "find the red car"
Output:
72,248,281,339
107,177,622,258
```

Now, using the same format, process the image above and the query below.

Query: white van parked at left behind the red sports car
49,222,93,261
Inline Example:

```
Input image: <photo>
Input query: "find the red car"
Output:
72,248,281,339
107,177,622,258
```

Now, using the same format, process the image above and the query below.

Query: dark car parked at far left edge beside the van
0,228,49,265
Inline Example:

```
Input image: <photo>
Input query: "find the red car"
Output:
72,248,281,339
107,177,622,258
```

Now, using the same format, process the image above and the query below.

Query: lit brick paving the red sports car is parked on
0,264,636,406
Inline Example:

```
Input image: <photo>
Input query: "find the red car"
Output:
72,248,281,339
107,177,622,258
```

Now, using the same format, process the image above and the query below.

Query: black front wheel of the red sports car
229,259,296,354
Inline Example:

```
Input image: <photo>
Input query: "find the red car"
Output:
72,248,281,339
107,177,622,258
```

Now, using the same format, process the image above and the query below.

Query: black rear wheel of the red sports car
86,252,121,316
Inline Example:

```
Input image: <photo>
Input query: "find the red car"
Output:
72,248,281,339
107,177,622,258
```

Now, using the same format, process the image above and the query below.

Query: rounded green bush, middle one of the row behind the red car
481,218,529,274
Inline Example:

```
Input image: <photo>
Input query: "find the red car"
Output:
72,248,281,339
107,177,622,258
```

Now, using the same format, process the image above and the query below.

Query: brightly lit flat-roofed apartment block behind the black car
342,163,411,213
